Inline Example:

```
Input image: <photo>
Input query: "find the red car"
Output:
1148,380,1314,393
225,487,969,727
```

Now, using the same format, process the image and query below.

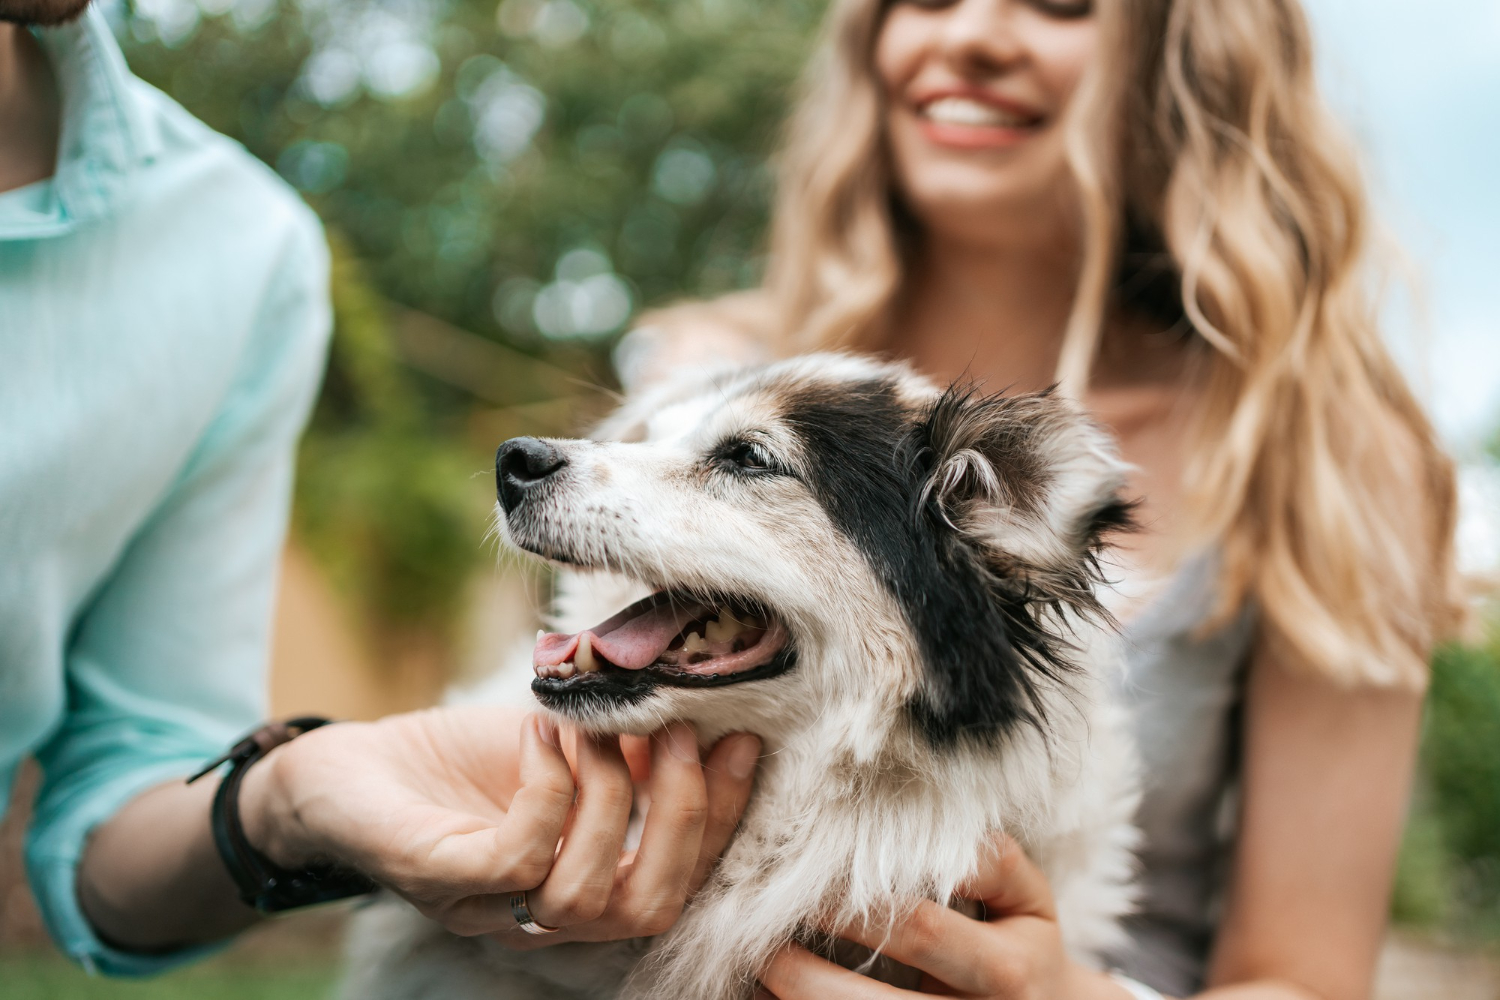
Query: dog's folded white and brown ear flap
921,387,1131,587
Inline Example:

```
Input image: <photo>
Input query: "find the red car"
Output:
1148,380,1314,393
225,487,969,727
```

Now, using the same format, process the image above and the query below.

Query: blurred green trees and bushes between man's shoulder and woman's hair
111,0,824,641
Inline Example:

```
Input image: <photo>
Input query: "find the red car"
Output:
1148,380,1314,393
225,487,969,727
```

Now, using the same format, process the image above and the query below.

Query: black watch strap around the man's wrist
188,715,377,913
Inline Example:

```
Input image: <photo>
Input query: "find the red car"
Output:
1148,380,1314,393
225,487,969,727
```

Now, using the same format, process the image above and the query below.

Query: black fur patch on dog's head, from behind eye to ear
782,379,1130,744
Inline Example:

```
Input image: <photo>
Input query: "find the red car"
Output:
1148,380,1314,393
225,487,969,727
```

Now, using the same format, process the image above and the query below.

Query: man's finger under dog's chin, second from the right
623,723,708,934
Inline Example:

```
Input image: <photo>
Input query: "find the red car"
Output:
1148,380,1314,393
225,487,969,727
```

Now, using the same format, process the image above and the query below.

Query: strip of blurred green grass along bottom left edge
0,954,338,1000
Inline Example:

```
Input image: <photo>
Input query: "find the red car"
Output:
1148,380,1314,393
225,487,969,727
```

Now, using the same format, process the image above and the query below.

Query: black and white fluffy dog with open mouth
345,355,1137,1000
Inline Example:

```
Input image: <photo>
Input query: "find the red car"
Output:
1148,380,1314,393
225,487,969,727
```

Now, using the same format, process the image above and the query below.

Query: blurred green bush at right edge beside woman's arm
1394,618,1500,939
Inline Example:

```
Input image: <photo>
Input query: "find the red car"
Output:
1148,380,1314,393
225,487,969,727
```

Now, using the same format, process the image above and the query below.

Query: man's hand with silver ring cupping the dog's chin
242,708,759,945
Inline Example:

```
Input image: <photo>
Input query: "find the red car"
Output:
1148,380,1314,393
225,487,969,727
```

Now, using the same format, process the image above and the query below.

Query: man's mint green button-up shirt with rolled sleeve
0,10,330,975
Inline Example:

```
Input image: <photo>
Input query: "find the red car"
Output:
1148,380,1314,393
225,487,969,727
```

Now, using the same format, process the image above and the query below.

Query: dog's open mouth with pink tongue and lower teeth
531,591,789,694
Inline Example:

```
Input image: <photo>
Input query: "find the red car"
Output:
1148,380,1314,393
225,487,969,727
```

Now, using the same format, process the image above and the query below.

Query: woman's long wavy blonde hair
647,0,1463,685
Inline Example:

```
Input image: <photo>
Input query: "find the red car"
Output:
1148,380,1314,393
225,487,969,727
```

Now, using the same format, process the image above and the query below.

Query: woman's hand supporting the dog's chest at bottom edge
761,837,1130,1000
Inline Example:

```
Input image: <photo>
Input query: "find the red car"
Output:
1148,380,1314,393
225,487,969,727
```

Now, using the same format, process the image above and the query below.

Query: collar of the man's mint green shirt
0,4,161,240
